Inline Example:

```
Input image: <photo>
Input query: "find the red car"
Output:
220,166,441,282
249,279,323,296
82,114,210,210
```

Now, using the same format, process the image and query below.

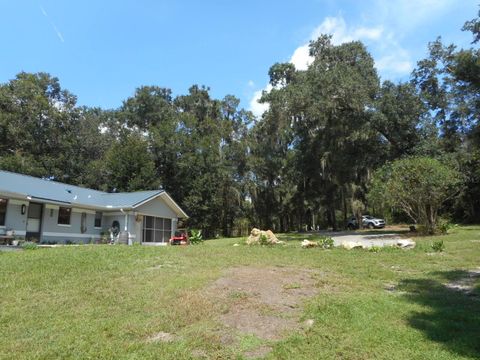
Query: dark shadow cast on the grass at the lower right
399,271,480,359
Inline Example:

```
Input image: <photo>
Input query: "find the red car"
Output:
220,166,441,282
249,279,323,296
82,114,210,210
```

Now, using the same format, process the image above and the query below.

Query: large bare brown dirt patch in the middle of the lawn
208,267,320,341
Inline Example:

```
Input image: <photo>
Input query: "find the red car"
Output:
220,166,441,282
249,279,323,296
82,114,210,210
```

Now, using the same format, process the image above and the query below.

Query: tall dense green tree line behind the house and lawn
0,9,480,237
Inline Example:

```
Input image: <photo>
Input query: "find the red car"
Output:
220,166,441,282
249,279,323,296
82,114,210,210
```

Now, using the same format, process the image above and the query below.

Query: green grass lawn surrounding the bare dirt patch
0,227,480,359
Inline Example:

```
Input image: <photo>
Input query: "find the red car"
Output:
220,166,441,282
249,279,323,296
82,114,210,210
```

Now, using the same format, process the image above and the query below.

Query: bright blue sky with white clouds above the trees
0,0,480,114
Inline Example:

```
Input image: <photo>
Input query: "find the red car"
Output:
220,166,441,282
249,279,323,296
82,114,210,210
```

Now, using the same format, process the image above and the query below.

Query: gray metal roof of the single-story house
0,170,171,213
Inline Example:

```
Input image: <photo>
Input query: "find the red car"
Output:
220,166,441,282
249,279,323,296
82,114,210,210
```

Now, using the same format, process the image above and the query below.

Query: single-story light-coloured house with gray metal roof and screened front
0,170,188,244
